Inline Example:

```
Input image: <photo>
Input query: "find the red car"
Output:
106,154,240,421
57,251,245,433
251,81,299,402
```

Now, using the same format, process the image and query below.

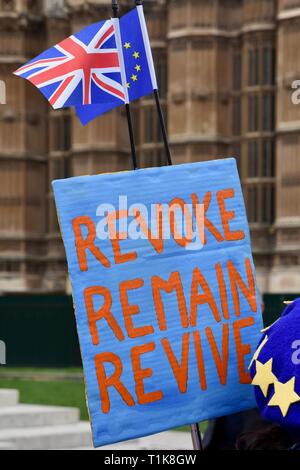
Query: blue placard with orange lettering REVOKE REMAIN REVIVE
53,159,262,446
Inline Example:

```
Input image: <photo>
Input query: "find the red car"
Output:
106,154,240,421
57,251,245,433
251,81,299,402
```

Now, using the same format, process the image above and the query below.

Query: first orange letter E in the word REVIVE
131,343,163,405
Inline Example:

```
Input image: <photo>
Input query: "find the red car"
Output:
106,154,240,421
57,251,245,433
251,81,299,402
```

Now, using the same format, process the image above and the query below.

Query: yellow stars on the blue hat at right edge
250,336,300,418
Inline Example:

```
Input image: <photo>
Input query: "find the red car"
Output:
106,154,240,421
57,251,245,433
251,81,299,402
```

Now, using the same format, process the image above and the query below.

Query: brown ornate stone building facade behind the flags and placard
0,0,300,294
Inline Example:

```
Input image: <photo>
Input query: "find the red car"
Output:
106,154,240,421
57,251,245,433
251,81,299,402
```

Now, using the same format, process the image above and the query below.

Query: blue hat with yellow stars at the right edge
250,299,300,439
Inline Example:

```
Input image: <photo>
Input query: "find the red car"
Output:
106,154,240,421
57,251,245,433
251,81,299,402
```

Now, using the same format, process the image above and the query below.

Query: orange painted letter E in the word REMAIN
120,279,154,338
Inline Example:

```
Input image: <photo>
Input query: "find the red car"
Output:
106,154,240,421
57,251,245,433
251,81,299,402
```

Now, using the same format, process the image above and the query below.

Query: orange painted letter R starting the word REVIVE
95,352,135,413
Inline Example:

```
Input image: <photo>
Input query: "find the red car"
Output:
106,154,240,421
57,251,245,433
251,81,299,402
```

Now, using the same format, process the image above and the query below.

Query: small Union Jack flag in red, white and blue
14,20,125,109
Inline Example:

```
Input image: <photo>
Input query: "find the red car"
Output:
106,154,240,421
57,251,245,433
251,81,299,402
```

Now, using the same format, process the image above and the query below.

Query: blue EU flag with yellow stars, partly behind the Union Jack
76,6,157,125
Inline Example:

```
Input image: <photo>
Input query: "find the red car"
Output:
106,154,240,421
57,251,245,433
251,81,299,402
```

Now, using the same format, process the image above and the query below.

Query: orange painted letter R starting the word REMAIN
84,286,125,346
